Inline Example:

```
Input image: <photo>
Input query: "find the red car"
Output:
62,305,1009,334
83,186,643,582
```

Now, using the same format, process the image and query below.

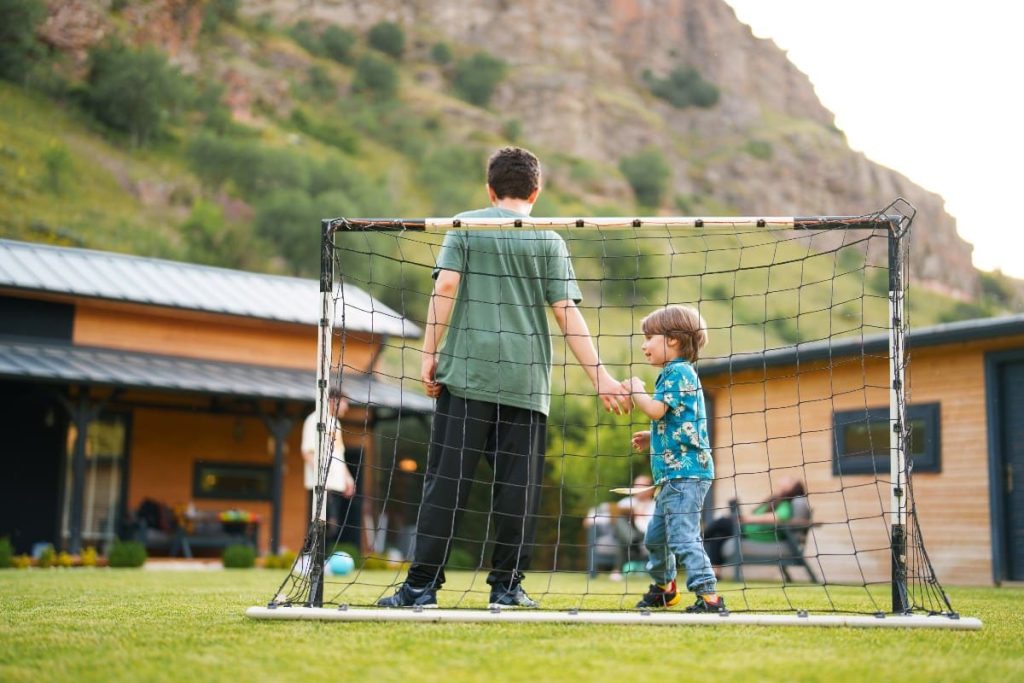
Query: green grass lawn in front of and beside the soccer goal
0,569,1024,683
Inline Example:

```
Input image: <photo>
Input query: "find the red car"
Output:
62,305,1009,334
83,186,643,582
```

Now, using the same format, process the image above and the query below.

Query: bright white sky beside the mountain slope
726,0,1024,278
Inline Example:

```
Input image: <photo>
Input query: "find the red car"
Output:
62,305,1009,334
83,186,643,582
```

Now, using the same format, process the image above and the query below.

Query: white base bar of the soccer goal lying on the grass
246,606,981,631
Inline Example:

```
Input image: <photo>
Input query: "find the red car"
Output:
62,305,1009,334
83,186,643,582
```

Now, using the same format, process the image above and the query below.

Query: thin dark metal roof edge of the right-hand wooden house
698,314,1024,377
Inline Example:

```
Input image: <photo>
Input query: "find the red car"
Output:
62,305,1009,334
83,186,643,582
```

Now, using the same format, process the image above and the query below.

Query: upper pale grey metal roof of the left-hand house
0,240,421,337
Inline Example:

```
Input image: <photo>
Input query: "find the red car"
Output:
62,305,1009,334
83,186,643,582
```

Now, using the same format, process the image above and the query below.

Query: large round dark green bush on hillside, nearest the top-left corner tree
85,43,190,144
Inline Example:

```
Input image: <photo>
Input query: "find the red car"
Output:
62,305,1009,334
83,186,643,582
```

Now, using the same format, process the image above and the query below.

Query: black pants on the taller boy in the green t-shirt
408,388,547,588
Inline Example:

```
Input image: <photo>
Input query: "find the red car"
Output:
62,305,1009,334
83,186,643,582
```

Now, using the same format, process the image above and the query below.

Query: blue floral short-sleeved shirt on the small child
650,358,715,484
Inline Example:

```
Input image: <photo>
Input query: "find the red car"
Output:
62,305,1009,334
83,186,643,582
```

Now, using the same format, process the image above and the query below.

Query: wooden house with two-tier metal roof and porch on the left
0,240,432,552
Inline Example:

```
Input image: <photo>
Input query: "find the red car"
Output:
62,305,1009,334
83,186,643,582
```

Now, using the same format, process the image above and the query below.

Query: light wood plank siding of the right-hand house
703,337,1024,585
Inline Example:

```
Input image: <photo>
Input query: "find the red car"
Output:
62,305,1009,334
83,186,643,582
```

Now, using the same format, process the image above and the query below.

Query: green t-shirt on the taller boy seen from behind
434,208,582,415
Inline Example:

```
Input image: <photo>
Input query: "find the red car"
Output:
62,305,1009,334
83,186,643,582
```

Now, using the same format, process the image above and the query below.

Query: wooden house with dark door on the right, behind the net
698,315,1024,585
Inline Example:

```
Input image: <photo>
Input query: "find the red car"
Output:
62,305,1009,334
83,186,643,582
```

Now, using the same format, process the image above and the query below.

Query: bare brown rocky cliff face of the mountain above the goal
37,0,978,298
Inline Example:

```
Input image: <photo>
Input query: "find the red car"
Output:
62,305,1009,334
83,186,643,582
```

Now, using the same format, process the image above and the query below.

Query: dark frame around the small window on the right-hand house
833,402,942,476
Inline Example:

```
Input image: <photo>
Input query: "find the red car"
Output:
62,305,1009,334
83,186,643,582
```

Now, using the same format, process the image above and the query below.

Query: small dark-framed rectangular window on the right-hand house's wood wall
833,403,941,474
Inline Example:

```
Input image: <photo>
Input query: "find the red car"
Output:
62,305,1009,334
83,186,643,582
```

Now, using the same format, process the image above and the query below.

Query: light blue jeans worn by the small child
644,479,717,595
